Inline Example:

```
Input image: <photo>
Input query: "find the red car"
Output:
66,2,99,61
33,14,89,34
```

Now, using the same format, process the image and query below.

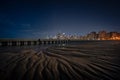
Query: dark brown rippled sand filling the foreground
0,41,120,80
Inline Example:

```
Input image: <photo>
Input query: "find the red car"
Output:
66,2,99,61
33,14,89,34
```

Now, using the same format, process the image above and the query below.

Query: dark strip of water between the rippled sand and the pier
0,41,120,53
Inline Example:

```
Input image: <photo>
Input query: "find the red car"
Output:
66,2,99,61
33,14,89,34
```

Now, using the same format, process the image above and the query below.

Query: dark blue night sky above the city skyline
0,0,120,39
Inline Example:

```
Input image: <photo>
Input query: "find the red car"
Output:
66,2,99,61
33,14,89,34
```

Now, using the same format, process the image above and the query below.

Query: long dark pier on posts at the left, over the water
0,39,68,46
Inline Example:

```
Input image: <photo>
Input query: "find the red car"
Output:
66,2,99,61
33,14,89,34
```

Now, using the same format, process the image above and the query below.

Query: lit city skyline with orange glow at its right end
49,31,120,40
